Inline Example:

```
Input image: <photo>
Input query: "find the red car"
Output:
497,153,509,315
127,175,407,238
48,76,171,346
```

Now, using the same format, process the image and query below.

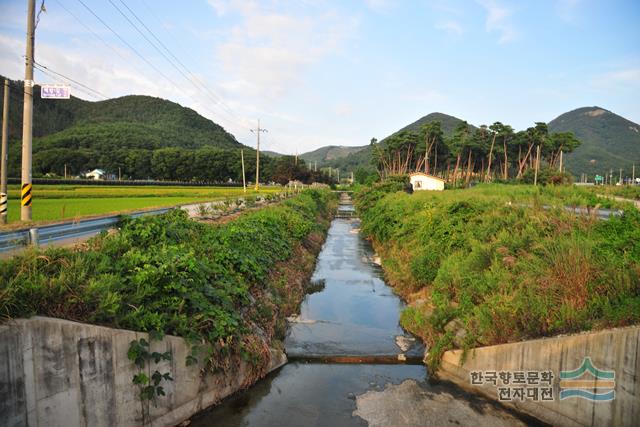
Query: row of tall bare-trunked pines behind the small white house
372,121,580,183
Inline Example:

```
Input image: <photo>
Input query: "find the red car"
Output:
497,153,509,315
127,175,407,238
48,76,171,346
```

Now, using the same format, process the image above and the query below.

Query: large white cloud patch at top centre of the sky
215,2,356,100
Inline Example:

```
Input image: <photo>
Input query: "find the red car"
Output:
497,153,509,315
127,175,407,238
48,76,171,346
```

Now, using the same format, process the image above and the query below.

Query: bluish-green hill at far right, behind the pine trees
549,107,640,179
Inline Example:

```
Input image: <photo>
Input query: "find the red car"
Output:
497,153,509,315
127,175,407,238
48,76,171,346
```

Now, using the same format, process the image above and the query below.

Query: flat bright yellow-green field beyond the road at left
1,185,283,224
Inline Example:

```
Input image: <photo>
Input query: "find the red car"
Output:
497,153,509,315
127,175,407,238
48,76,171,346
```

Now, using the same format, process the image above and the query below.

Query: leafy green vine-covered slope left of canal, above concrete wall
0,190,335,372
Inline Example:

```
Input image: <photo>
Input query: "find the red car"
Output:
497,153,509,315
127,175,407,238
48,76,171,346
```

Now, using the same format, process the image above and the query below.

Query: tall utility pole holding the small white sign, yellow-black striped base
20,0,36,221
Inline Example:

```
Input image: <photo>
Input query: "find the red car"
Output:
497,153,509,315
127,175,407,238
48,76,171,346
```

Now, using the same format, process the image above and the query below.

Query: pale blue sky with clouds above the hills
0,0,640,153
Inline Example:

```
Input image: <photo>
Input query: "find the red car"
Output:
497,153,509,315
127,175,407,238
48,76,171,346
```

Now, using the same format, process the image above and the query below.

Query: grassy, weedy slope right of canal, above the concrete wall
356,184,640,368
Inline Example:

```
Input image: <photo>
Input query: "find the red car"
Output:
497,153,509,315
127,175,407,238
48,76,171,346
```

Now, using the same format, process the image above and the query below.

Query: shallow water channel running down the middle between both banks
190,194,530,427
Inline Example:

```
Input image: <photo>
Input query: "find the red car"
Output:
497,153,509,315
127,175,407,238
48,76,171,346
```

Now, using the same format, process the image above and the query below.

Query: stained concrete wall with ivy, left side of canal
0,317,286,427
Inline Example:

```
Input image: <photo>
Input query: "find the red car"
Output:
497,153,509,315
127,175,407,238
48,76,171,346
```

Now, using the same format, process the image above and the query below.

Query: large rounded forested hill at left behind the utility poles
3,74,242,178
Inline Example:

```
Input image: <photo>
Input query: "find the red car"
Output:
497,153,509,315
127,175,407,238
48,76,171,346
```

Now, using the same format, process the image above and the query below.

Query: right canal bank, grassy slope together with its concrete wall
356,183,640,426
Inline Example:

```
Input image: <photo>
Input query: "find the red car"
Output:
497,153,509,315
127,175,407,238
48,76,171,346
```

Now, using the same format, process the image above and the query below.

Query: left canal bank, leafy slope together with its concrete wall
0,192,335,426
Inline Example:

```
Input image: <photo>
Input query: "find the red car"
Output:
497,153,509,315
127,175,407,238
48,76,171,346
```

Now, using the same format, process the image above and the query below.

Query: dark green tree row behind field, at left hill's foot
9,147,331,184
